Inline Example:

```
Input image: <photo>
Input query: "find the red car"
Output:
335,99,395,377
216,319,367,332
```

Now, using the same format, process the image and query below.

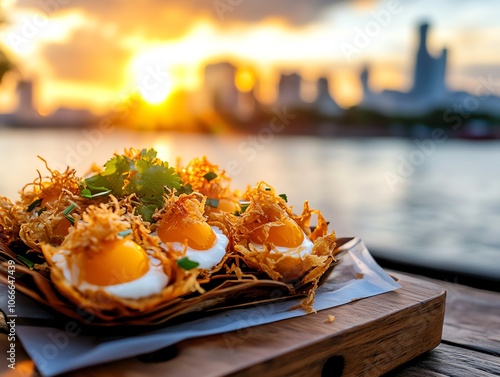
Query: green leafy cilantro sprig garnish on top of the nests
80,149,184,221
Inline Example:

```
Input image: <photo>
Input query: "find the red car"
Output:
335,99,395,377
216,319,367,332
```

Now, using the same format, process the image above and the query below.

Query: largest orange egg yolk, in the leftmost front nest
80,239,149,286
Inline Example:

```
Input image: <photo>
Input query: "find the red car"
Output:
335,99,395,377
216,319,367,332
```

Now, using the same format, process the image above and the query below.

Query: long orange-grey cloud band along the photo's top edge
17,0,340,39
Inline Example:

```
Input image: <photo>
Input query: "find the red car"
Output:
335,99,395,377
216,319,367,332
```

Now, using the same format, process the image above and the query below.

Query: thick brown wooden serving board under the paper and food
0,275,445,377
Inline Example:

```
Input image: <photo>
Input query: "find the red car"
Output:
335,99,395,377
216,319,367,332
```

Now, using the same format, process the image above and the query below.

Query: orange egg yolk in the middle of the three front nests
158,221,216,250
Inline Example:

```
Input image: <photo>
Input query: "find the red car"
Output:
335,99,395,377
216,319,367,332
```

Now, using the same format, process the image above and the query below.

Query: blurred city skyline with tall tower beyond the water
0,19,500,130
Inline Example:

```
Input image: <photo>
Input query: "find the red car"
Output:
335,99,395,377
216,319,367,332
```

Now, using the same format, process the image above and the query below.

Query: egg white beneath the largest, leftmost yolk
52,250,168,299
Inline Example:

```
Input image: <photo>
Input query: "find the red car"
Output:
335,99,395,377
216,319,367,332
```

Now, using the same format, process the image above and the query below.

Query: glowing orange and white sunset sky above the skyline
0,0,500,114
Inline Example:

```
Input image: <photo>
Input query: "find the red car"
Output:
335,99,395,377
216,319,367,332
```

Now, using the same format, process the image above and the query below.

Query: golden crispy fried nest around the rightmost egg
234,182,336,311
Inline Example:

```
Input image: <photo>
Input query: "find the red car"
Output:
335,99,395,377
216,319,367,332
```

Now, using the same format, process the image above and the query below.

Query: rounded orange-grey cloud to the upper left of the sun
42,29,131,87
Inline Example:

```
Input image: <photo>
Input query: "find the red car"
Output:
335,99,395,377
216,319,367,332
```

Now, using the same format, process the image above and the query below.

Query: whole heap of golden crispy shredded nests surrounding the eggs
0,154,335,326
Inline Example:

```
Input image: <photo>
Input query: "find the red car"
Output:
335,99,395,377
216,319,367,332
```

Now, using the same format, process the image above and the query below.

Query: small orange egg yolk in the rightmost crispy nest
251,218,304,247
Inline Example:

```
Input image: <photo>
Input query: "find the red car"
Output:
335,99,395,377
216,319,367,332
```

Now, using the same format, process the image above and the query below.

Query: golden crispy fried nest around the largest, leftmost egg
42,199,203,319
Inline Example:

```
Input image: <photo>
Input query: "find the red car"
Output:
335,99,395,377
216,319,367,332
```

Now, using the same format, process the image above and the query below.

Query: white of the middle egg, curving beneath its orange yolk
151,226,229,270
